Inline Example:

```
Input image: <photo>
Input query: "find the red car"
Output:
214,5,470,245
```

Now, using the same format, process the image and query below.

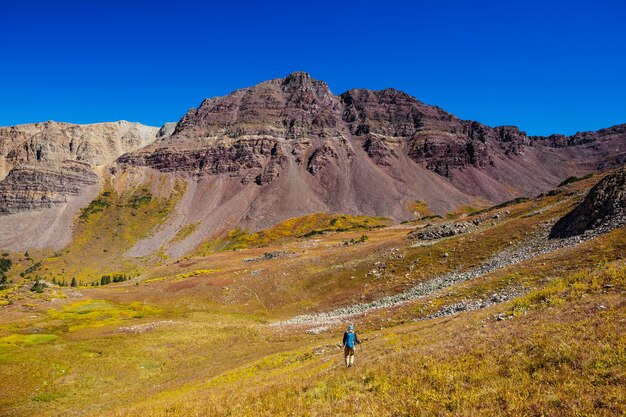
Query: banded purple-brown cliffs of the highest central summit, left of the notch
117,72,347,185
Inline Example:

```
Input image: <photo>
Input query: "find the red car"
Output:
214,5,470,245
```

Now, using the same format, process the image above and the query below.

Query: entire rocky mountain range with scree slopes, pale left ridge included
0,72,626,256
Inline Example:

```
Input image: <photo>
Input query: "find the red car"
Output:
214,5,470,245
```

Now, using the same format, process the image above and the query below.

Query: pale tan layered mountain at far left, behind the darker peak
0,121,160,249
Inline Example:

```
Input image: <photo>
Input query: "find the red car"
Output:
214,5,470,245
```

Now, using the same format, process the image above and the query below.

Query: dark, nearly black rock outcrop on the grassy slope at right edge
550,168,626,238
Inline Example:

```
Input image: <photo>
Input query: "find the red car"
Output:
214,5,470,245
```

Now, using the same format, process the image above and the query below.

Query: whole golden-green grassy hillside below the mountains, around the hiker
0,170,626,417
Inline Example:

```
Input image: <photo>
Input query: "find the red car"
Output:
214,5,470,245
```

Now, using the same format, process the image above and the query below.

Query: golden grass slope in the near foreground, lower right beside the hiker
108,263,626,416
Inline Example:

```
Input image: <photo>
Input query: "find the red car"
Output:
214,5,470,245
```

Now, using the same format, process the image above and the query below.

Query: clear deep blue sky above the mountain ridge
0,0,626,134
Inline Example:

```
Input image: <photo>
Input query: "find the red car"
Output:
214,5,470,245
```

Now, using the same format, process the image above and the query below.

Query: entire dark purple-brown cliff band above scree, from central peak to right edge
119,72,626,188
